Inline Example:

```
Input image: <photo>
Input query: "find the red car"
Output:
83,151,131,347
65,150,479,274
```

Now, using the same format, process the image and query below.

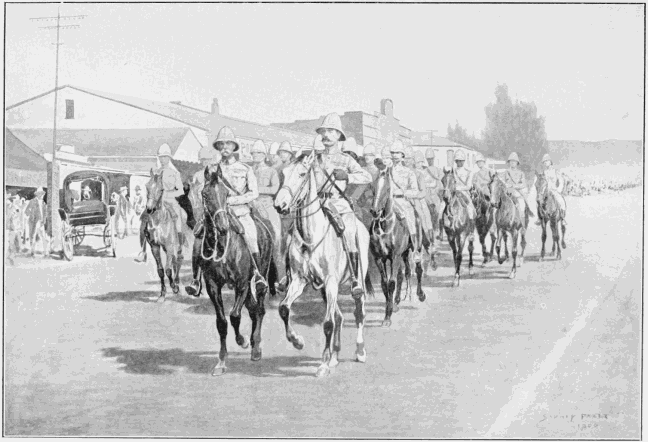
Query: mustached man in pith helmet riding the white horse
315,113,371,296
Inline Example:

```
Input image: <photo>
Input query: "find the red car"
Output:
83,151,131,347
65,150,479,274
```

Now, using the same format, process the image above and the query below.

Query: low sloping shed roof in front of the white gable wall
11,127,191,157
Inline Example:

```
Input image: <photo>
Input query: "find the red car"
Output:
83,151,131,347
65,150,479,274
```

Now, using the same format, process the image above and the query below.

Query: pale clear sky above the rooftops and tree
5,4,645,141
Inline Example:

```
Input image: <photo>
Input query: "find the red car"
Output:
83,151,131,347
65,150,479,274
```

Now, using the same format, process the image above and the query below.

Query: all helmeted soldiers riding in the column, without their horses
135,113,566,296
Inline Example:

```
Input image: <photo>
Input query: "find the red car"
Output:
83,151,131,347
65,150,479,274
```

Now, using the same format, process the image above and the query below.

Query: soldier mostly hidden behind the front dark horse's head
185,146,221,297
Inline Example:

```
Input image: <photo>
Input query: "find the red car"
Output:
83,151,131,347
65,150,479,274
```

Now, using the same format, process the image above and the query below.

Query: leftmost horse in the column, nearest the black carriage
144,169,186,302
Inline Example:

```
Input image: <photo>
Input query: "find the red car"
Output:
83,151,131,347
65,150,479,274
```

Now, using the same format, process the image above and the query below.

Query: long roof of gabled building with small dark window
6,85,211,130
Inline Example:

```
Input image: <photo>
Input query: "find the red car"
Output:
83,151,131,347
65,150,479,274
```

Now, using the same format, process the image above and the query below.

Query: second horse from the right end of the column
489,174,529,279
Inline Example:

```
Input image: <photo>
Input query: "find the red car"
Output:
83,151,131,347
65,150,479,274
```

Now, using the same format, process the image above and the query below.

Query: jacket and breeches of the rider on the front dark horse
220,157,259,253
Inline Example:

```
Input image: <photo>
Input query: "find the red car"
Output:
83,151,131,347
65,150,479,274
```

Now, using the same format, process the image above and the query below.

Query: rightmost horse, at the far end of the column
535,173,567,261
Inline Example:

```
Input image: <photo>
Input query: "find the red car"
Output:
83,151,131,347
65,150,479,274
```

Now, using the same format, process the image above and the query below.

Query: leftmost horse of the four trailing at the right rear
441,169,475,287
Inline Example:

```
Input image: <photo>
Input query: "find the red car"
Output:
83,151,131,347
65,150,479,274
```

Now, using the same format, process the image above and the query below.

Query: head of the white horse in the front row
274,151,315,214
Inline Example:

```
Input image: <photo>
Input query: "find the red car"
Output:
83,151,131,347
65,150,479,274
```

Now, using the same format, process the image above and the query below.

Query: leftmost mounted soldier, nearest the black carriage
135,143,184,262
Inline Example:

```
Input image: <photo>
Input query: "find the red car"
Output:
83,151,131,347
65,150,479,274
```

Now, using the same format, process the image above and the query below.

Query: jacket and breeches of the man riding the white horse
315,147,371,253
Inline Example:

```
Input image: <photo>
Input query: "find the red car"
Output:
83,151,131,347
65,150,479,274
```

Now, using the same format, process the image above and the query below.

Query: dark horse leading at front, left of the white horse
196,167,277,376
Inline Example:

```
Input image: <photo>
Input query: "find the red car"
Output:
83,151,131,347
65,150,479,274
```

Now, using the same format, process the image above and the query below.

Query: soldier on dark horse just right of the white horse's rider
378,140,421,263
